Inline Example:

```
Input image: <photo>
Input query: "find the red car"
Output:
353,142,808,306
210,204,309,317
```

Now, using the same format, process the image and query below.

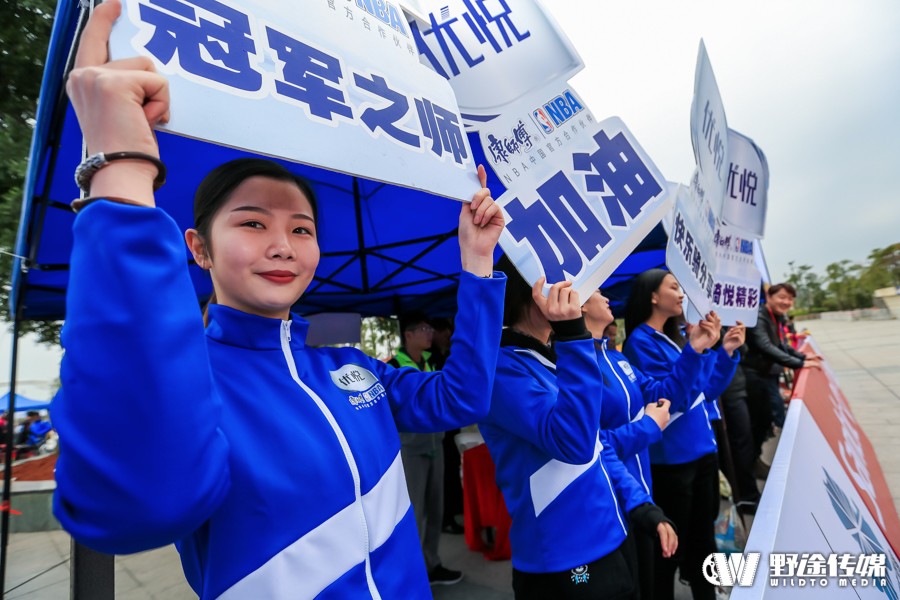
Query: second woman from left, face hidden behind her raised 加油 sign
478,257,677,600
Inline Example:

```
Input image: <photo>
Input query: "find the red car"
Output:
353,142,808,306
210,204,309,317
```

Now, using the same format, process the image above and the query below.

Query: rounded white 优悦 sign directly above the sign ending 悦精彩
722,129,769,238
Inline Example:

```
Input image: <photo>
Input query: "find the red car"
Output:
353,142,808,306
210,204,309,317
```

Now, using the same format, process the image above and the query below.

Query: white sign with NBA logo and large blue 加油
480,83,671,301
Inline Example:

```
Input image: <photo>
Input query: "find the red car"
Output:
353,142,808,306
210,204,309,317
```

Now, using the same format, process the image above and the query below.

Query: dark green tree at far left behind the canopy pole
0,0,59,343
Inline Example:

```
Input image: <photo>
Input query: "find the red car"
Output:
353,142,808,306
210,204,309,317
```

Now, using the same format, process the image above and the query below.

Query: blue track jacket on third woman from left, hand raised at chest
594,338,708,495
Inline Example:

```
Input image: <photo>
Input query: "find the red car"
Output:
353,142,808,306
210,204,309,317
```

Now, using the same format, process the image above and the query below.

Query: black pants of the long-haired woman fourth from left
650,453,719,600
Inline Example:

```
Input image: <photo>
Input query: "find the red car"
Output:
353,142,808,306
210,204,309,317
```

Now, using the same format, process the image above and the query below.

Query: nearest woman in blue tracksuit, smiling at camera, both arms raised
53,1,504,599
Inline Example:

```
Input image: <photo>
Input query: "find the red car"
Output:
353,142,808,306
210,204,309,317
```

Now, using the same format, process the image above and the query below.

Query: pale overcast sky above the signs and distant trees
543,0,900,281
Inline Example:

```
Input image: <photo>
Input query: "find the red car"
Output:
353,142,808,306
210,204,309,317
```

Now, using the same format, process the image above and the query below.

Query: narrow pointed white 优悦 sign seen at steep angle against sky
691,40,728,219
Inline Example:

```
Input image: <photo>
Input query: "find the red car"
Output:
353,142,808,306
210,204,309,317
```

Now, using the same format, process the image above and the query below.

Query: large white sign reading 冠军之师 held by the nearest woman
110,0,479,200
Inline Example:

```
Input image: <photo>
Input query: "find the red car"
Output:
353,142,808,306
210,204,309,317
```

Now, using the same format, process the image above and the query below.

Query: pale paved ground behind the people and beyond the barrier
5,321,900,600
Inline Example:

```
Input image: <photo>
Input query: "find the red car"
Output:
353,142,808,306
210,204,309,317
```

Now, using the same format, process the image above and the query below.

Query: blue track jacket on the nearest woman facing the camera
52,201,505,600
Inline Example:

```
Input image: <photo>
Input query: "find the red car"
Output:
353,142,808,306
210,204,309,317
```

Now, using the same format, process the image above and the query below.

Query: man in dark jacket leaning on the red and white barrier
742,283,820,455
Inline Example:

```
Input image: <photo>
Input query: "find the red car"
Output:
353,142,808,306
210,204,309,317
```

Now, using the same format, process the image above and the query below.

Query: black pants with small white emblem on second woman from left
513,538,638,600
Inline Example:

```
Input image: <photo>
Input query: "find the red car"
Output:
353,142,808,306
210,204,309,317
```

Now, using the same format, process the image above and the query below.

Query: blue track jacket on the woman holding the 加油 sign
478,329,651,573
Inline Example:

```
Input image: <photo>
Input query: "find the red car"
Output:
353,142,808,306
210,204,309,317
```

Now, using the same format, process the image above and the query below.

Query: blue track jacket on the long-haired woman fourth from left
623,323,740,465
